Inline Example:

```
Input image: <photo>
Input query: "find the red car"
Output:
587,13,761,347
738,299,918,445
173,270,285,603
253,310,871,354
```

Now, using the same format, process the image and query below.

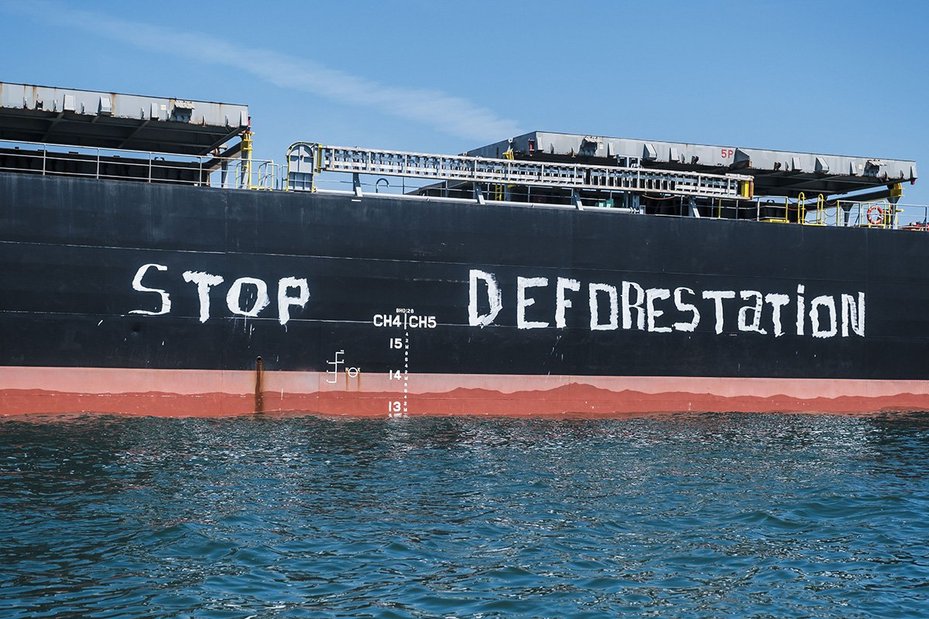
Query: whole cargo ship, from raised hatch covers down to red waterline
0,83,929,417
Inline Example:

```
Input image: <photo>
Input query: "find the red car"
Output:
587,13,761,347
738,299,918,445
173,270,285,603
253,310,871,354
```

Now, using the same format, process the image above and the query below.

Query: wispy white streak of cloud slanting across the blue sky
0,1,520,141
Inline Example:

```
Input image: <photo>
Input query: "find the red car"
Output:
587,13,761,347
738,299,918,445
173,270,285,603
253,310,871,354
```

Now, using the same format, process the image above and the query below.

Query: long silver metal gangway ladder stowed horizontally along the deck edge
287,142,753,199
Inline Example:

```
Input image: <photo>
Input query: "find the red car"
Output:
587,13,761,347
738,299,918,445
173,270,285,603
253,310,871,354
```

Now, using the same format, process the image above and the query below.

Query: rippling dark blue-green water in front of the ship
0,414,929,618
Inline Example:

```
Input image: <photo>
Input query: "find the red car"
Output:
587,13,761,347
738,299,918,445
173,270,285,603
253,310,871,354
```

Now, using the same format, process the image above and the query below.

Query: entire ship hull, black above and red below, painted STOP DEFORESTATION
0,174,929,416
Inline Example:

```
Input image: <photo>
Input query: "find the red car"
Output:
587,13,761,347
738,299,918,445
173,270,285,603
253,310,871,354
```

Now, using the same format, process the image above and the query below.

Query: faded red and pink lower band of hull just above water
0,367,929,418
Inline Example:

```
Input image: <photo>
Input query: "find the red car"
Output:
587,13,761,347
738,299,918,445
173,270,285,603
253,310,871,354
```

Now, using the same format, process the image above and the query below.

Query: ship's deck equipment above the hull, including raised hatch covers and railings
0,83,929,230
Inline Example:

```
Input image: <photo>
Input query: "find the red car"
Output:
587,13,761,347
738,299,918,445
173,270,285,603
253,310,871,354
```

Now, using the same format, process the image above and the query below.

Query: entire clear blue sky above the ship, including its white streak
0,0,929,203
